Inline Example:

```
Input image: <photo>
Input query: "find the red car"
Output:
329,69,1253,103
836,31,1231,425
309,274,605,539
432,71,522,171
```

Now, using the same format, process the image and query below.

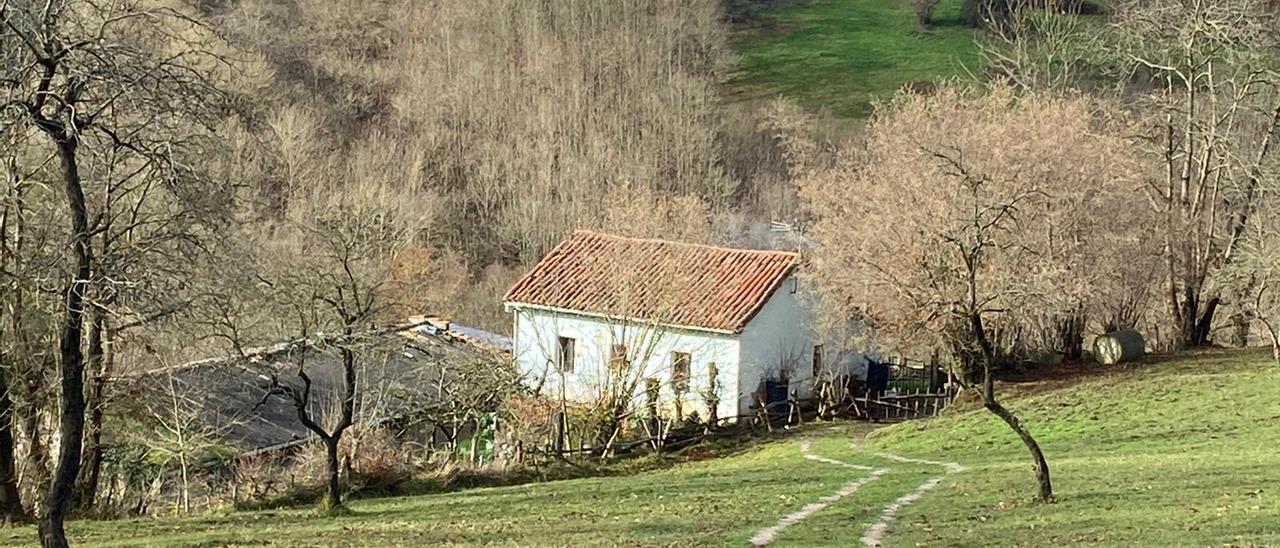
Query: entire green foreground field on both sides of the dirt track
0,351,1280,547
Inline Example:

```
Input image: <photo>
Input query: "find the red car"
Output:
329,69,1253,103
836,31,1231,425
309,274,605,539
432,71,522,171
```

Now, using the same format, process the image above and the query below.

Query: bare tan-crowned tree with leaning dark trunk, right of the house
803,87,1134,501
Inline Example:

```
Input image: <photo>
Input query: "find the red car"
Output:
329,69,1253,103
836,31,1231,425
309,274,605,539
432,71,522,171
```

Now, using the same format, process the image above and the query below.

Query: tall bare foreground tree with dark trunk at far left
0,0,230,547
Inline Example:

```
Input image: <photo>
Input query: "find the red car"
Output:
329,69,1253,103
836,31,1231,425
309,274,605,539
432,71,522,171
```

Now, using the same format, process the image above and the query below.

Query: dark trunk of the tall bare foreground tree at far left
40,136,92,548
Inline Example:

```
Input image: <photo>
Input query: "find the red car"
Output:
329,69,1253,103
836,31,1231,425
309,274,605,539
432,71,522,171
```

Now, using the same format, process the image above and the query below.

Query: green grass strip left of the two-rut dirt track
0,424,922,545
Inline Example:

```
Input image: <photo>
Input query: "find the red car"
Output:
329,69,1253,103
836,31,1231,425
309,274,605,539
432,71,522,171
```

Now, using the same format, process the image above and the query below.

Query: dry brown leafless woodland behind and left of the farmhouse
0,0,795,532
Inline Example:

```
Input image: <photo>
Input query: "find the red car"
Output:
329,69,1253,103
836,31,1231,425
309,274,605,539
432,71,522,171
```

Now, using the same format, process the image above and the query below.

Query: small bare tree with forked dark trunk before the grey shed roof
250,186,422,512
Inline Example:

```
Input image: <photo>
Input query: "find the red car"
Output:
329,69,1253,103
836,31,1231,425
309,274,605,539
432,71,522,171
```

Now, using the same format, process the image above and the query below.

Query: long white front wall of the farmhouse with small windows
511,305,740,419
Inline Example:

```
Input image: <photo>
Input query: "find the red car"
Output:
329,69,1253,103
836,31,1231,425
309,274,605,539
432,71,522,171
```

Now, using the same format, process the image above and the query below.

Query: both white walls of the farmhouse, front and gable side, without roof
511,275,867,419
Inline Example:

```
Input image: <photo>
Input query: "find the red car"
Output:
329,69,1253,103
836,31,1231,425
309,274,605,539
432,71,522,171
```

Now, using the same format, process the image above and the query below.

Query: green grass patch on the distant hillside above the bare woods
730,0,980,118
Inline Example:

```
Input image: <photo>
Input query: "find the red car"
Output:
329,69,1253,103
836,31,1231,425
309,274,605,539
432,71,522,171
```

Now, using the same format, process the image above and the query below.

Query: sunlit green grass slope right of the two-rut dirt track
868,351,1280,545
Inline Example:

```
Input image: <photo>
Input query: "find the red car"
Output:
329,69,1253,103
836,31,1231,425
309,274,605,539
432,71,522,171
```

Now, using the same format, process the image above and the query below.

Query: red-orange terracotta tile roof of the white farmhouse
503,230,800,333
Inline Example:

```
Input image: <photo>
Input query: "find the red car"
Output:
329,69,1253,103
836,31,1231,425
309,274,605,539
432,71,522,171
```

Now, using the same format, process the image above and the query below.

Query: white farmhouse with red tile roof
504,230,861,417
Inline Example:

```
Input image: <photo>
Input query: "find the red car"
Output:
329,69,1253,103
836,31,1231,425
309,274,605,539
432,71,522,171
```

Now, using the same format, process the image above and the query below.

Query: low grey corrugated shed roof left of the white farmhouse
113,318,509,455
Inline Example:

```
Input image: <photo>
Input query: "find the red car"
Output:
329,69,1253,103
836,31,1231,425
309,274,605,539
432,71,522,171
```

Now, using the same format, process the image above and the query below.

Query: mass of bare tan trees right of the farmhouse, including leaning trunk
794,0,1280,501
